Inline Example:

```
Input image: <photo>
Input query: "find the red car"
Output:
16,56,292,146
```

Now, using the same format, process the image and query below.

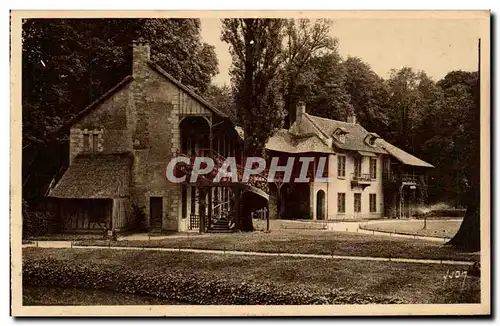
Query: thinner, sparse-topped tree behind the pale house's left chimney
283,19,338,127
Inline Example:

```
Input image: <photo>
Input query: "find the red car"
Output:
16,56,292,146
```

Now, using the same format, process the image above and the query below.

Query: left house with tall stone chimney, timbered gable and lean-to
49,42,248,231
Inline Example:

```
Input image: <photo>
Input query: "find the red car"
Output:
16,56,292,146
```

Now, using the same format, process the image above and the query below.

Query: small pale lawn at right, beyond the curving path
363,220,462,238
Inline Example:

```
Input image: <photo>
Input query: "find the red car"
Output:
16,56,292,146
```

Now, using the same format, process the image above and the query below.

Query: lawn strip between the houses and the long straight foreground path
76,230,479,261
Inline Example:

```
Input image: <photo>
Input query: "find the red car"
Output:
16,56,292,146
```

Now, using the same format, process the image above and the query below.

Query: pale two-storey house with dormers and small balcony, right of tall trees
267,103,432,220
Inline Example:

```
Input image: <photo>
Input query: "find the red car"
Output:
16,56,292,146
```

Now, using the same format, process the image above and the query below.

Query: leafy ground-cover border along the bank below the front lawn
23,258,404,305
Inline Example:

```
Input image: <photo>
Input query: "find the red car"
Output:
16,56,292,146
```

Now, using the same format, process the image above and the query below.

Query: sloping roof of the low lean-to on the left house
49,153,132,198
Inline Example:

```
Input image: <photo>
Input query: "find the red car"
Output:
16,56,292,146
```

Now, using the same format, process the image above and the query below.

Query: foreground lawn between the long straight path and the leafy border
23,248,480,303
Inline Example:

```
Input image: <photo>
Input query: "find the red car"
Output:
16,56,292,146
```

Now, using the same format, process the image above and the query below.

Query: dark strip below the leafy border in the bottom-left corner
23,286,184,306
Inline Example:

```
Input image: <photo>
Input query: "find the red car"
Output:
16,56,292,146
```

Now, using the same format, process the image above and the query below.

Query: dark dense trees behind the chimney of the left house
22,19,218,146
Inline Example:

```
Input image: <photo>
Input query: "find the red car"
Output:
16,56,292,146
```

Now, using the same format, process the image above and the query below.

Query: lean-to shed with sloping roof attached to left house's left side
48,154,132,232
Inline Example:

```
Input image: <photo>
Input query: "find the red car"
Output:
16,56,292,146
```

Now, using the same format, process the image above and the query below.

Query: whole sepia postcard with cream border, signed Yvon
10,11,491,316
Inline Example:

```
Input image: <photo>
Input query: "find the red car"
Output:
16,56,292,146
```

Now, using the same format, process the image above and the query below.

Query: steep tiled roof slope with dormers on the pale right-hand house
306,114,387,154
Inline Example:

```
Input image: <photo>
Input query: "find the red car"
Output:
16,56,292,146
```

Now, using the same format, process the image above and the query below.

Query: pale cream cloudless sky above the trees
201,18,480,85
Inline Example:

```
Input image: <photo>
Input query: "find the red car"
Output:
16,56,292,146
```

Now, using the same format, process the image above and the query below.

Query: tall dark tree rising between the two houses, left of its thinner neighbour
221,19,284,156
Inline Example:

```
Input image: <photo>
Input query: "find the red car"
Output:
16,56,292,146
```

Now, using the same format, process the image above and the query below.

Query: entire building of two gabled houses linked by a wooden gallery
49,42,431,232
